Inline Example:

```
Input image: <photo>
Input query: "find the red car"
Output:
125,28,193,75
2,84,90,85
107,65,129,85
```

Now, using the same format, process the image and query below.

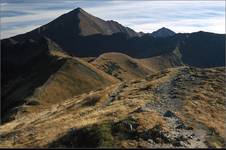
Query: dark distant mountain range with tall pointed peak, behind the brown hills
2,8,225,67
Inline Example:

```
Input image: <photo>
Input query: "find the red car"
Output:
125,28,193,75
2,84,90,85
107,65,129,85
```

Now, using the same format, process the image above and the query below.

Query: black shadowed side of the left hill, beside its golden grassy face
1,38,64,120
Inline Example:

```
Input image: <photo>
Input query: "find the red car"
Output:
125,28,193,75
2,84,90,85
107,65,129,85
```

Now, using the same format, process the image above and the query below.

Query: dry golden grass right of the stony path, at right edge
178,68,226,139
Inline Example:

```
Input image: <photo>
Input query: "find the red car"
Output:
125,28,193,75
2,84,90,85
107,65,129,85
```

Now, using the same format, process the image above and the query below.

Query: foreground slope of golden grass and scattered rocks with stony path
0,67,226,148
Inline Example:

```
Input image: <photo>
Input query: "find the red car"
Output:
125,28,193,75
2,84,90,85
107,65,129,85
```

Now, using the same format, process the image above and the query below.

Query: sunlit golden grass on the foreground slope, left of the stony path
0,81,154,147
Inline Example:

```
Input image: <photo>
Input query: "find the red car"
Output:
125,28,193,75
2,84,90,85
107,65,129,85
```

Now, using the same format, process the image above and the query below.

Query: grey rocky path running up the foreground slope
138,68,210,148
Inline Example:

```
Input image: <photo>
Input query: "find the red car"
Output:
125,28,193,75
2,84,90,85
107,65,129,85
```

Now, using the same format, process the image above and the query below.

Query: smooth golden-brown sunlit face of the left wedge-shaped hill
33,58,120,104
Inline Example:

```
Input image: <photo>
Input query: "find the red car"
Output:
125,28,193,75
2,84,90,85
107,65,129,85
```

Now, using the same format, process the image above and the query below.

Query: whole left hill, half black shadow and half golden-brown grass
1,39,117,121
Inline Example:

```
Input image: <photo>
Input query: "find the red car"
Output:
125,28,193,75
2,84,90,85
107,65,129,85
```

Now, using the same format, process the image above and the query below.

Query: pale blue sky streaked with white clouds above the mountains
0,0,225,39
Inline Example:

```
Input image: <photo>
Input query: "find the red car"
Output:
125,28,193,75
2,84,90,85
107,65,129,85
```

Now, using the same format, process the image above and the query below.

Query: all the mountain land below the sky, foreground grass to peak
0,8,226,148
